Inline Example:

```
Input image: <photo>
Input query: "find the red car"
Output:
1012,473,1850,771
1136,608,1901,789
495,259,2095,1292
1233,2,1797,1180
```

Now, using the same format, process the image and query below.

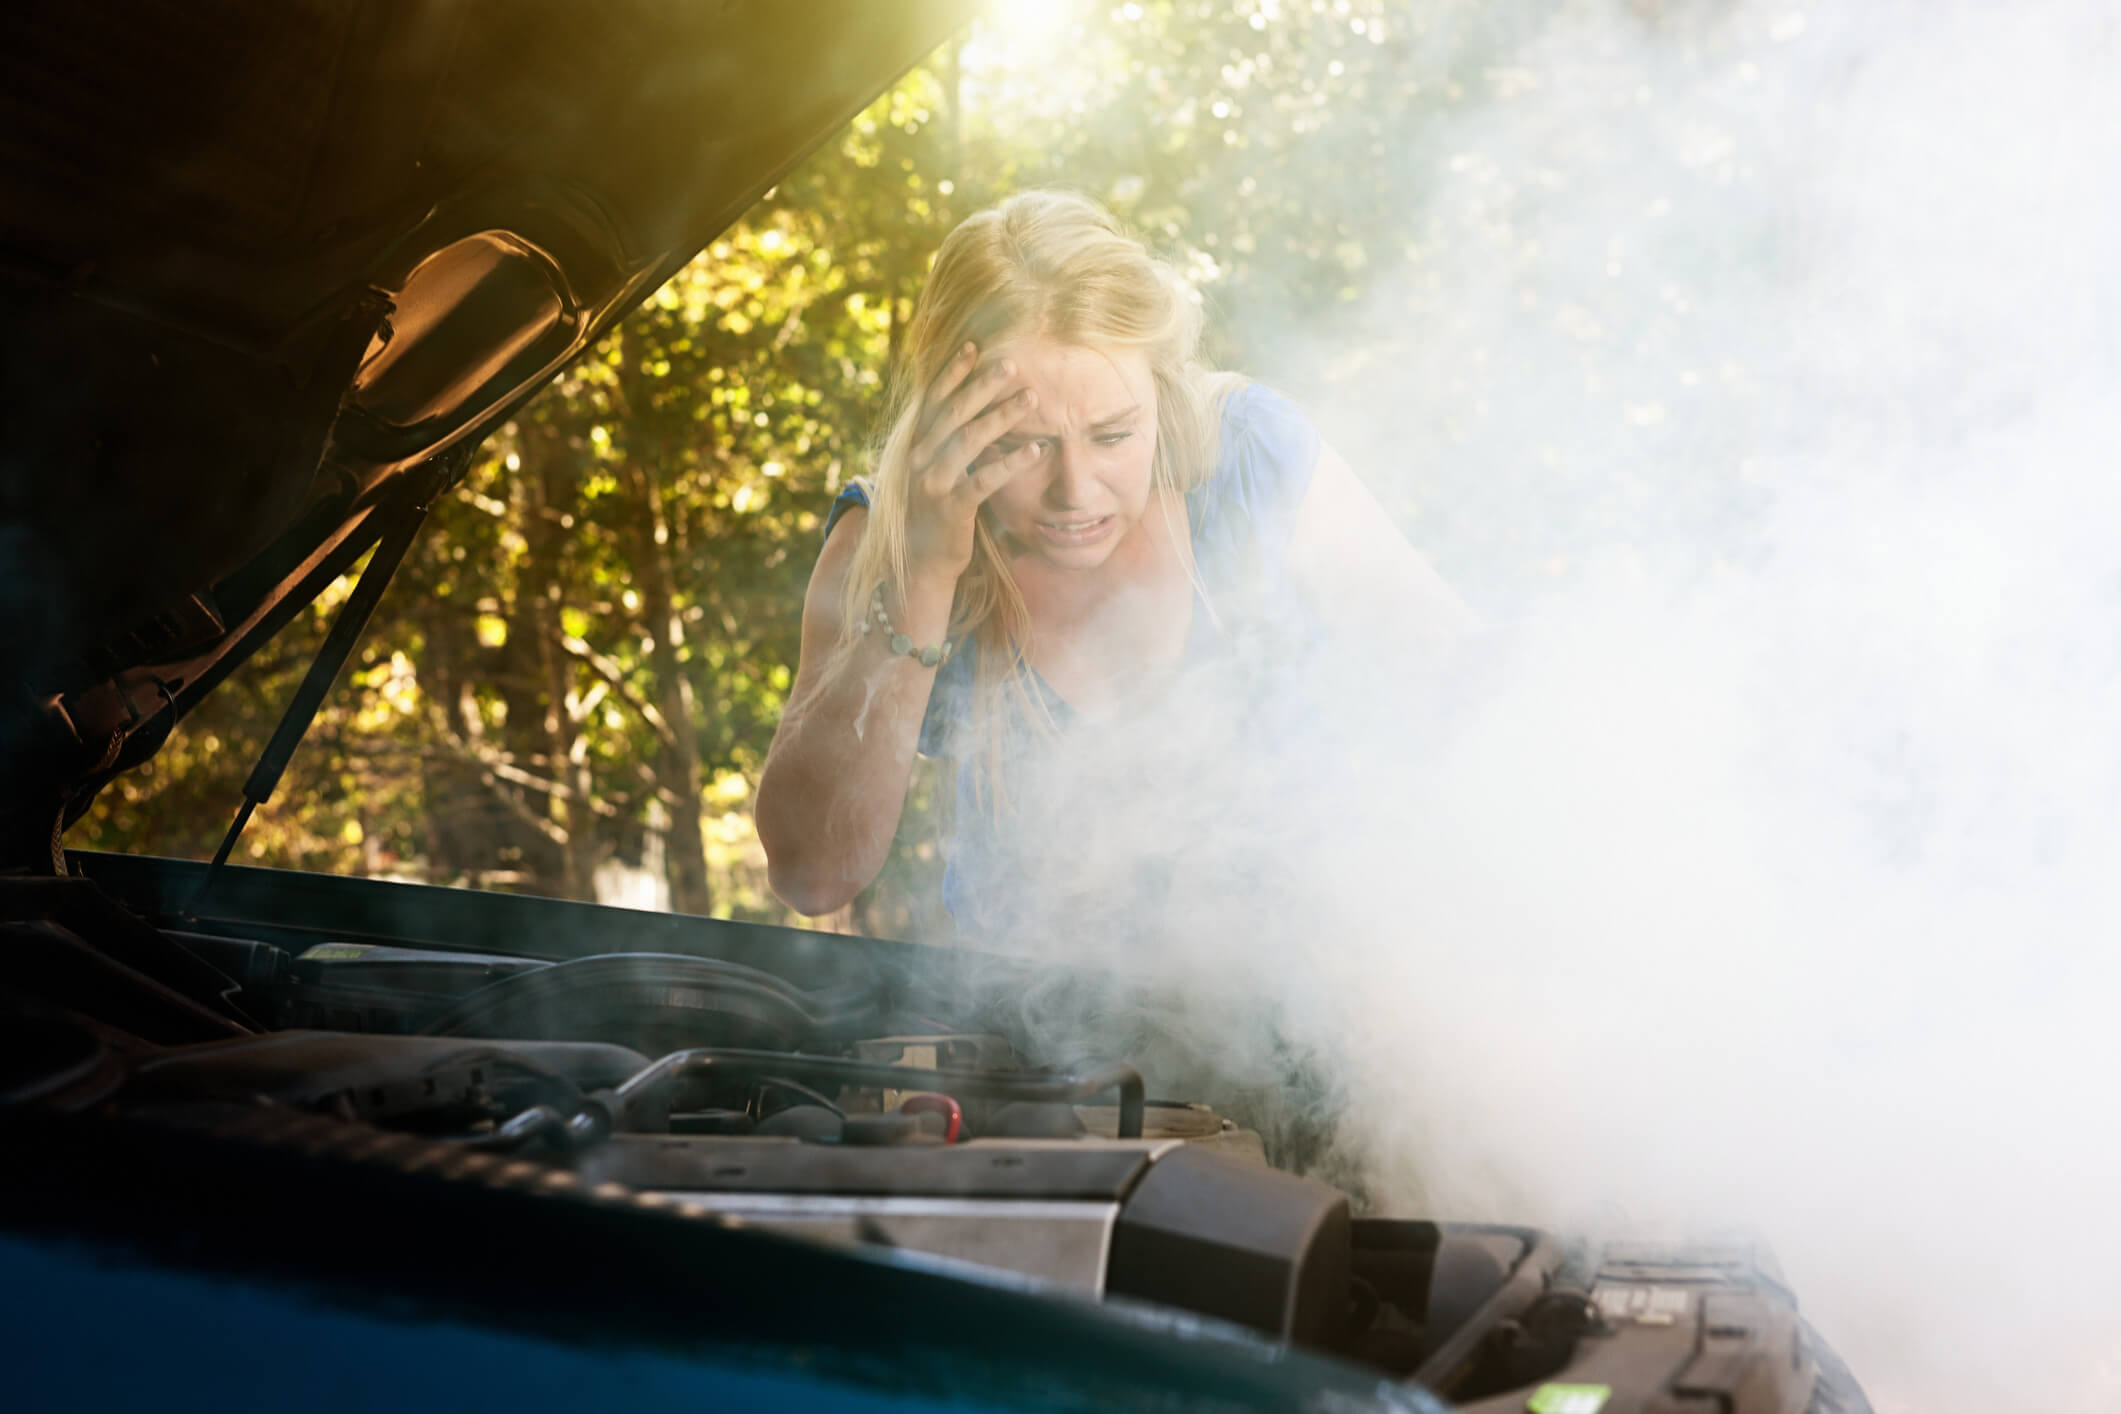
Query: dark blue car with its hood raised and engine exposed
0,0,1860,1414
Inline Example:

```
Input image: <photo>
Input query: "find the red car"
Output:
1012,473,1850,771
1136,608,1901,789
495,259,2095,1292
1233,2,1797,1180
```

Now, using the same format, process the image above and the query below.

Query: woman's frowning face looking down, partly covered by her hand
986,339,1156,570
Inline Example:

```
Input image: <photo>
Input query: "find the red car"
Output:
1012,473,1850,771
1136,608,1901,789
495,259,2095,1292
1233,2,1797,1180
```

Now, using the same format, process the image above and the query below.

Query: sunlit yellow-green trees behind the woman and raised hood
68,0,1741,939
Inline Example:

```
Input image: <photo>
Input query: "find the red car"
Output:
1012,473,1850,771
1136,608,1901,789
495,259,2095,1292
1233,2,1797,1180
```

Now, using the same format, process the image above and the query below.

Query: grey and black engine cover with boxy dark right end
579,1136,1349,1346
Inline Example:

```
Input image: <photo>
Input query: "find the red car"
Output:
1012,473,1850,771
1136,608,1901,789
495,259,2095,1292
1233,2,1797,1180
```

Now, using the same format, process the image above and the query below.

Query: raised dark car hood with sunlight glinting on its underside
0,0,974,869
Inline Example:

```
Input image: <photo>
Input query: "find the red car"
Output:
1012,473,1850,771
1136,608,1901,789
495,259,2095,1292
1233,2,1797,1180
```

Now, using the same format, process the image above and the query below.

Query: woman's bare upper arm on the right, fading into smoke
1290,445,1478,649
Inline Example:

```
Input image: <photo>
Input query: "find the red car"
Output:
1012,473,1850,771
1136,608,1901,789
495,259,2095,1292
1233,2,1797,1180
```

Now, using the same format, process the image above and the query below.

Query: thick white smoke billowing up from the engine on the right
971,0,2121,1410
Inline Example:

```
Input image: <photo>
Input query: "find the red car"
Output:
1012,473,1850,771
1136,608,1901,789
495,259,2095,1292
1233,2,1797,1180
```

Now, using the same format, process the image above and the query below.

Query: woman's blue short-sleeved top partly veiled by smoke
825,384,1319,941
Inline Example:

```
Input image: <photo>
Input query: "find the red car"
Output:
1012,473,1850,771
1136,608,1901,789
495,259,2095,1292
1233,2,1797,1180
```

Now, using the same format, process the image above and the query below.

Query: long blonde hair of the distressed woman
840,191,1237,803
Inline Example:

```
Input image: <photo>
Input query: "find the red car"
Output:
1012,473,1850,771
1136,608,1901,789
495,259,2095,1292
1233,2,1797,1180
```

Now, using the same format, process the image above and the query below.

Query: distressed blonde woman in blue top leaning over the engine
757,191,1466,933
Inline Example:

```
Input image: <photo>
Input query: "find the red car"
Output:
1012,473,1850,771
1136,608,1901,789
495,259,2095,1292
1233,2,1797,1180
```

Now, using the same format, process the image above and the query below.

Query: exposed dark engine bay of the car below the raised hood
0,864,1862,1412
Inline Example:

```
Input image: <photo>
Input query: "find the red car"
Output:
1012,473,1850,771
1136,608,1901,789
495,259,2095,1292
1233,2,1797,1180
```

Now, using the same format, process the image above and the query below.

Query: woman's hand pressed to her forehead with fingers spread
906,343,1037,587
